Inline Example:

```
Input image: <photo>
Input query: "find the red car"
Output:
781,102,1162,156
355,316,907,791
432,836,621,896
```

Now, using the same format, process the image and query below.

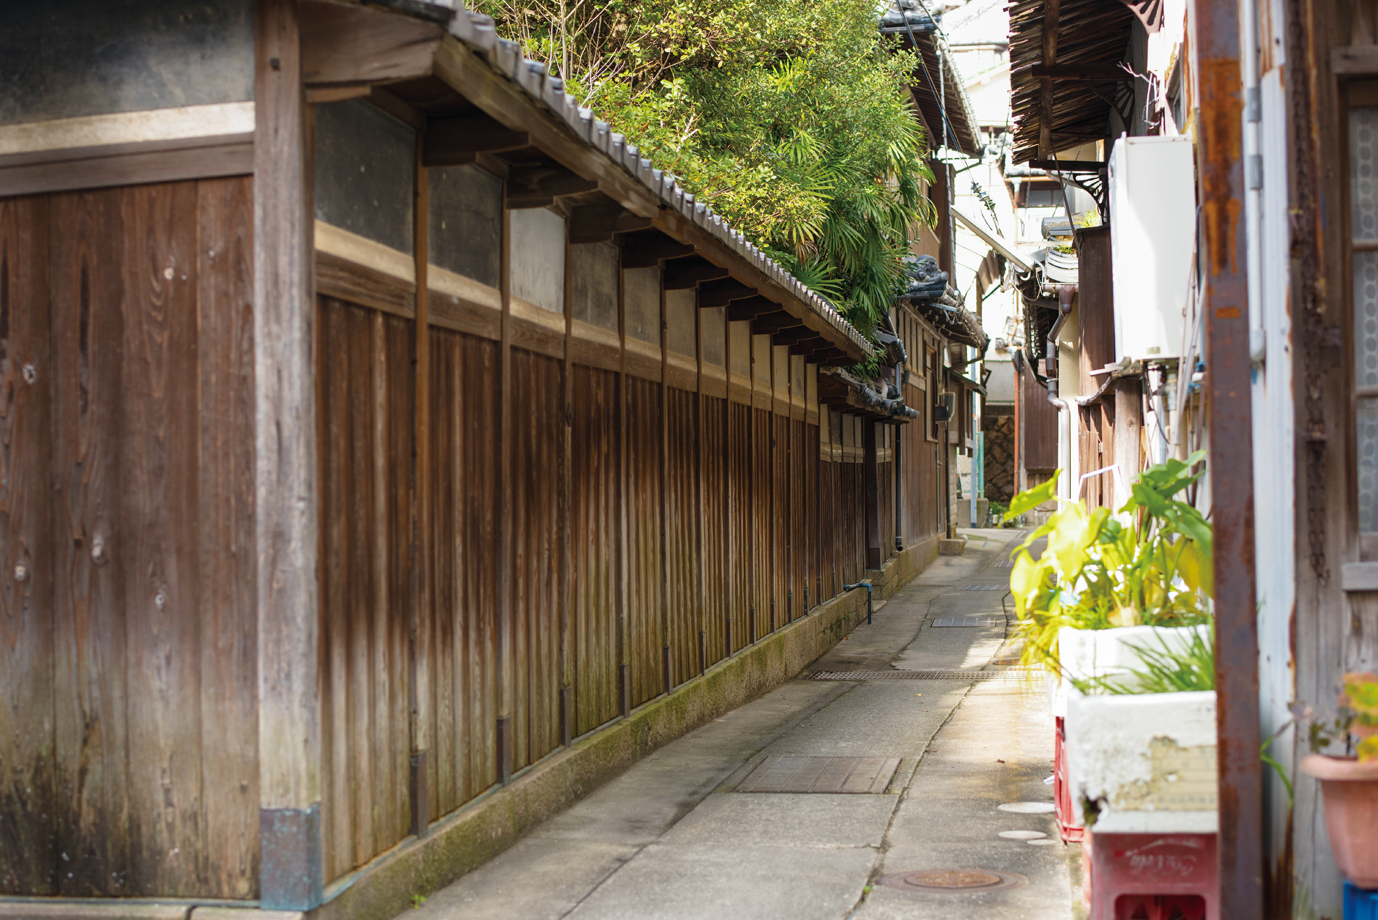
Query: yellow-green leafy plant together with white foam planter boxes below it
1010,453,1215,840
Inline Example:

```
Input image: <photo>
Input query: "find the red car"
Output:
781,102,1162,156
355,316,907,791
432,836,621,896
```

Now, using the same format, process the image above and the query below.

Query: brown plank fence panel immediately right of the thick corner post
320,297,413,879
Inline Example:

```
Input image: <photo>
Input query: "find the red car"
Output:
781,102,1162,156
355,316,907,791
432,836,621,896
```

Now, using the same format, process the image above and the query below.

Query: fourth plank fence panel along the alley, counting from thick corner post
570,365,617,734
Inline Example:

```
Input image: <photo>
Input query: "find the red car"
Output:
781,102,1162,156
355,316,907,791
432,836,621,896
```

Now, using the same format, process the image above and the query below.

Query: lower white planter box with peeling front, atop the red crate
1067,691,1218,833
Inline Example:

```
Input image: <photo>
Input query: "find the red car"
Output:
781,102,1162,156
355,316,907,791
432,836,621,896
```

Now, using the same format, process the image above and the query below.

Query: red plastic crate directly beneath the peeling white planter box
1082,833,1220,920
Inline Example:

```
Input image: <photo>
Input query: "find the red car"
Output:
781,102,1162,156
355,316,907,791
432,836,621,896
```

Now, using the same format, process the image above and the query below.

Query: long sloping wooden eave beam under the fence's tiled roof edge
433,37,865,361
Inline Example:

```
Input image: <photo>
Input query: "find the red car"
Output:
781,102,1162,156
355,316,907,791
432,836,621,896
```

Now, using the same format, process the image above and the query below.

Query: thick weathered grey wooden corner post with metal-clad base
254,0,324,910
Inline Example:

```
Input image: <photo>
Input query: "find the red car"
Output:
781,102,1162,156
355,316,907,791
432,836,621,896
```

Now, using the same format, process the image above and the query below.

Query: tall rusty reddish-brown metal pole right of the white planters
1192,0,1265,917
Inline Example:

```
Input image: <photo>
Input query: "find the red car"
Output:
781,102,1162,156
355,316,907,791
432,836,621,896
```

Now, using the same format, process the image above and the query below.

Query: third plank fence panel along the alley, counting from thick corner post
510,348,564,770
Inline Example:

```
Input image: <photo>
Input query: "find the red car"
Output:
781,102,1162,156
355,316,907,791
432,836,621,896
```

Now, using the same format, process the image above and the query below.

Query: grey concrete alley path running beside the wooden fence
411,530,1079,920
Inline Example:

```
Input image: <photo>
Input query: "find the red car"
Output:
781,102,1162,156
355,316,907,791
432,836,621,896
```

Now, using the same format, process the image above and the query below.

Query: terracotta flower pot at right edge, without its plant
1301,753,1378,890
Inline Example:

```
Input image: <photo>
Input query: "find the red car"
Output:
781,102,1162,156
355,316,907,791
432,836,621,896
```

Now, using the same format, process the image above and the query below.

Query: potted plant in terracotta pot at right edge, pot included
1301,672,1378,890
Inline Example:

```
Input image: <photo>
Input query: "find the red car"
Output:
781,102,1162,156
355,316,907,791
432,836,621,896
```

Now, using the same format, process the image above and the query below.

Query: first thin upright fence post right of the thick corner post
408,128,433,837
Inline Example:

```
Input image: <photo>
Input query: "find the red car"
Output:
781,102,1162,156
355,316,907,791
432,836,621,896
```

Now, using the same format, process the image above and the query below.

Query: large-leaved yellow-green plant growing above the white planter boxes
1006,452,1214,672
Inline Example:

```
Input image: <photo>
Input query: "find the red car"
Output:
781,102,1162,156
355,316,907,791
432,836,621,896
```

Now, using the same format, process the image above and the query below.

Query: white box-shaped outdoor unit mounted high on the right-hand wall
1109,136,1196,361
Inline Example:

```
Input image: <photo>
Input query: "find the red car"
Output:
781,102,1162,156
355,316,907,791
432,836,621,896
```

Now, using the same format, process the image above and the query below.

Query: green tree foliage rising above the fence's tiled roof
477,0,933,331
